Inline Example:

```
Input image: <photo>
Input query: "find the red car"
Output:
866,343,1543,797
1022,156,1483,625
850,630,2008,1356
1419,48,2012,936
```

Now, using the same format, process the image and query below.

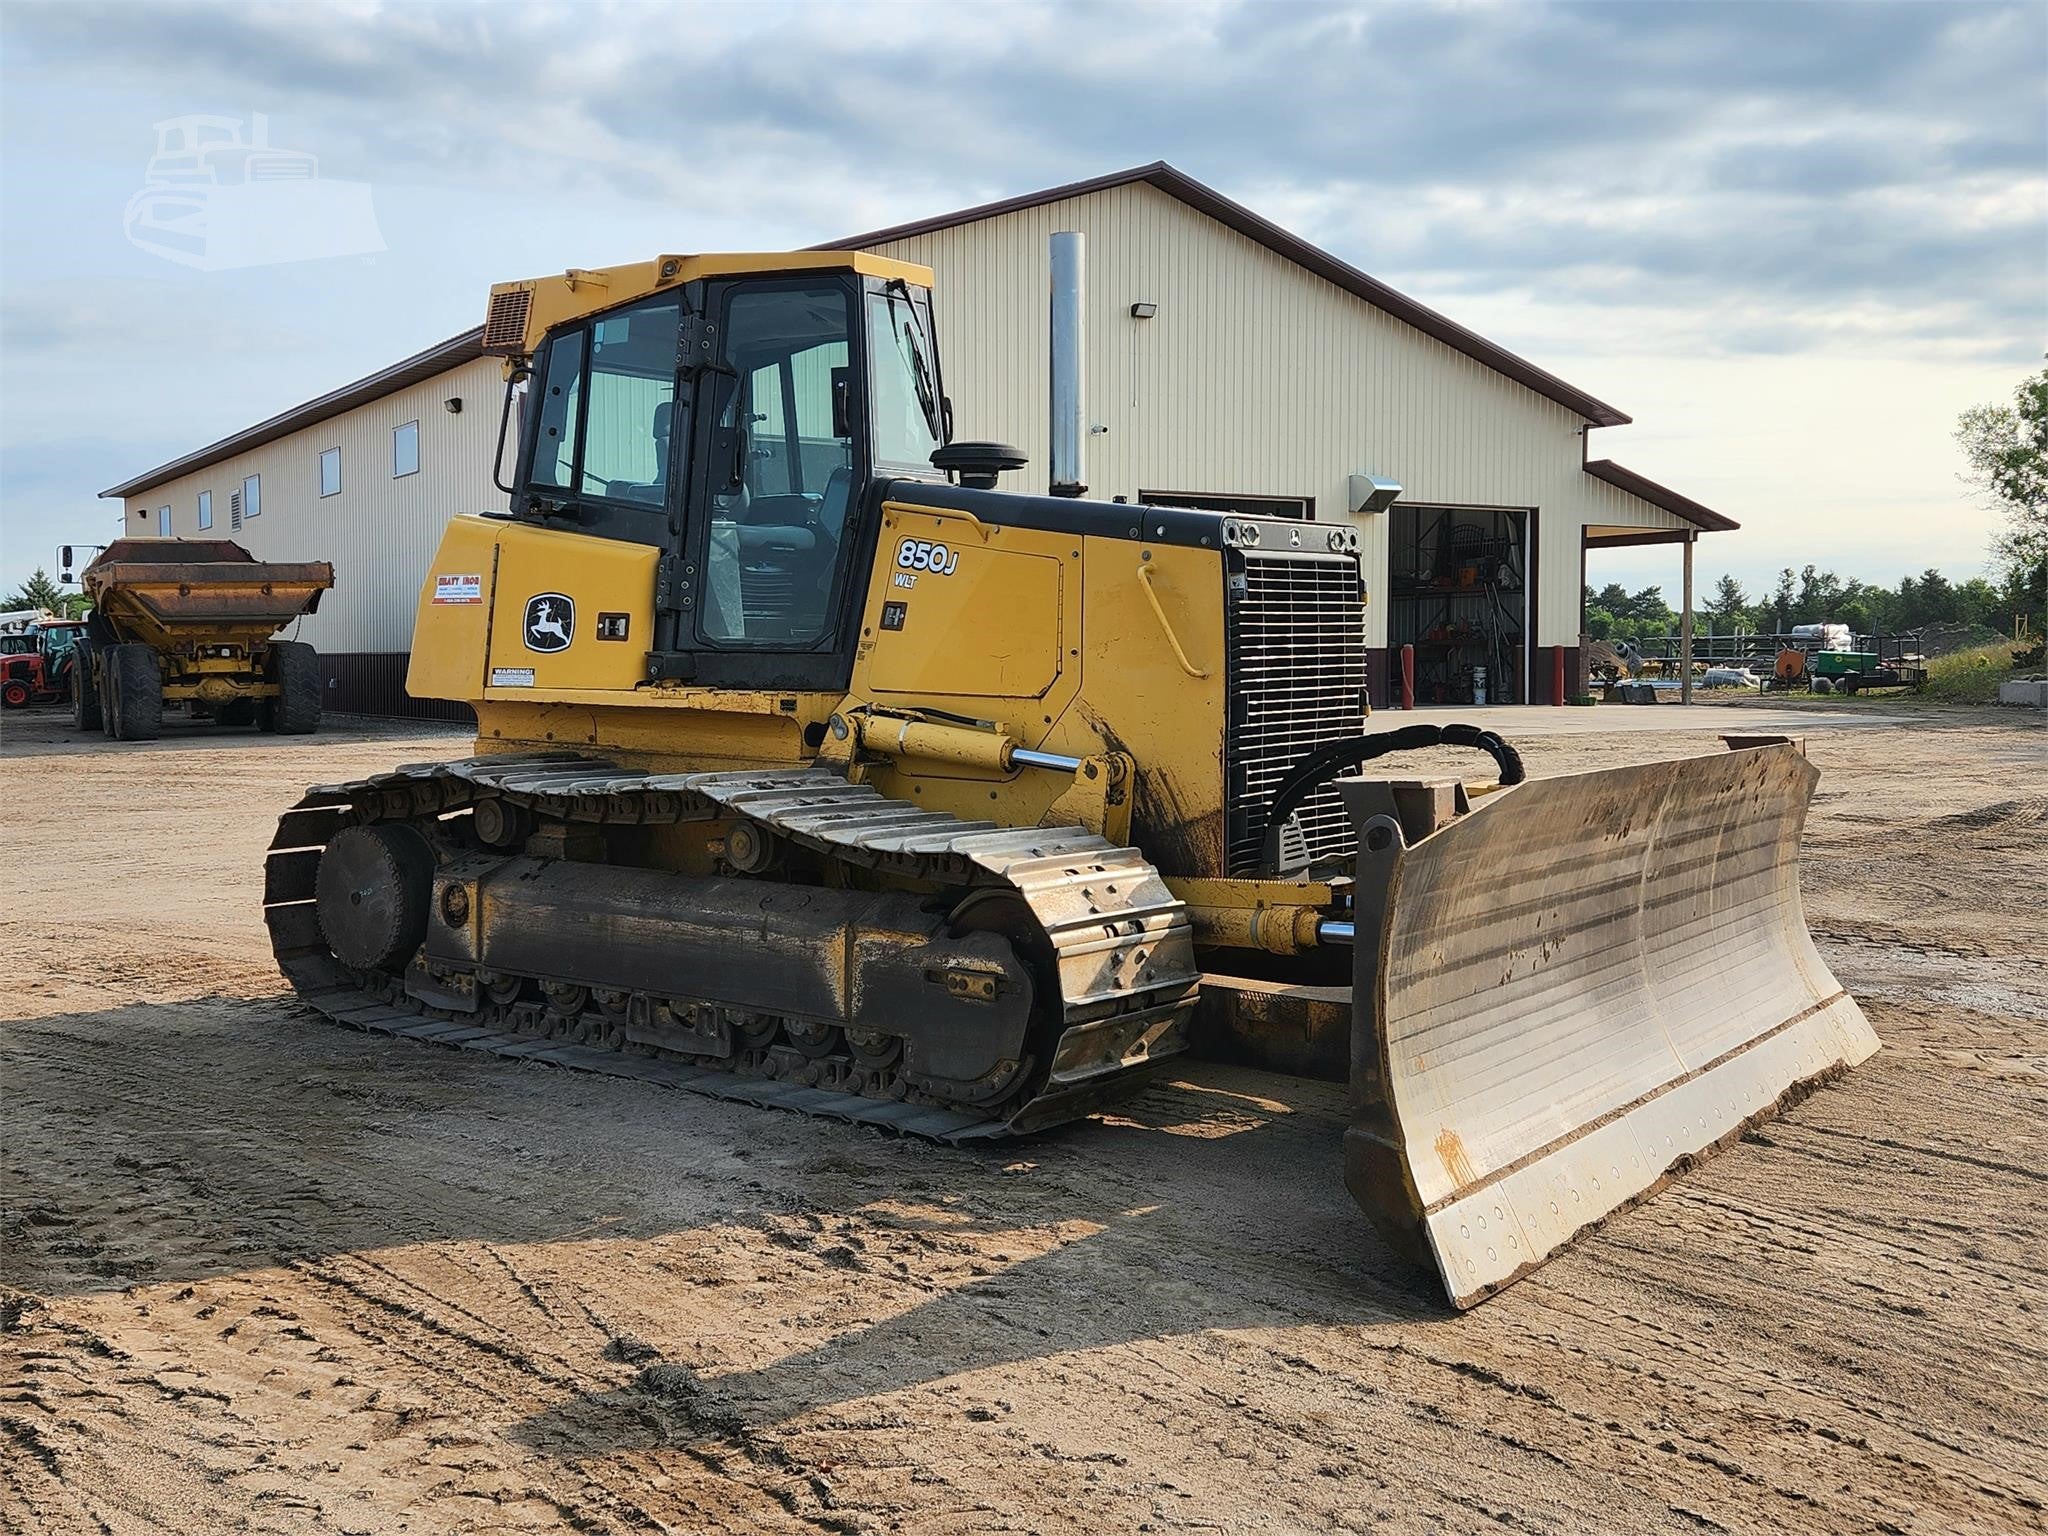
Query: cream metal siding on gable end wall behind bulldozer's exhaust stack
856,182,1686,645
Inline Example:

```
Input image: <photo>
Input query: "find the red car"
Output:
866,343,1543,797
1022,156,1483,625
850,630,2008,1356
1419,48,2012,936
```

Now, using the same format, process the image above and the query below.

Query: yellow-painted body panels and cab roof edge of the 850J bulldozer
408,252,1294,876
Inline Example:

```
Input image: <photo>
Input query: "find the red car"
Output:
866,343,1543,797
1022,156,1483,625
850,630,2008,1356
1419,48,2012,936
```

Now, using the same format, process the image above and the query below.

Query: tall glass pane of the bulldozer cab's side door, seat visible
698,285,854,651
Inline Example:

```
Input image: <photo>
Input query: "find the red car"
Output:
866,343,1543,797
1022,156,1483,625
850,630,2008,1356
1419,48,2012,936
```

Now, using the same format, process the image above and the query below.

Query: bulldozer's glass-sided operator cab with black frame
508,254,948,686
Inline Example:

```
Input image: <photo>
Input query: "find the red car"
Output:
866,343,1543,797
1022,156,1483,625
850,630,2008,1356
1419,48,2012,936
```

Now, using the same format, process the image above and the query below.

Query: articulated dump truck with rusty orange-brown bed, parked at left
66,539,334,741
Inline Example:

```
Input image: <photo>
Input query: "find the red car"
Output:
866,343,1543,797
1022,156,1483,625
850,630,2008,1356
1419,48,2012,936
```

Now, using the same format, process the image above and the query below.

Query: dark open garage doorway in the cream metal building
1386,504,1530,705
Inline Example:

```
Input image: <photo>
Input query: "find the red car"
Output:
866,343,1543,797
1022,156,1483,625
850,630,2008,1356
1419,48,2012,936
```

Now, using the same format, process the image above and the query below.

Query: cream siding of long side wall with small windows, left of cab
123,358,512,655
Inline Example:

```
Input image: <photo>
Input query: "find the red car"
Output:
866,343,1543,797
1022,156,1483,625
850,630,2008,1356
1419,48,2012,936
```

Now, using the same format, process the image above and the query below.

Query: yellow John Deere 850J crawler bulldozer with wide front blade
266,252,1876,1307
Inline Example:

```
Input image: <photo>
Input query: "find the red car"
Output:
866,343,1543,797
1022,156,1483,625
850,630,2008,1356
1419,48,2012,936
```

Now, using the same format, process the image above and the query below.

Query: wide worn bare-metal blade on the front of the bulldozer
1339,743,1878,1307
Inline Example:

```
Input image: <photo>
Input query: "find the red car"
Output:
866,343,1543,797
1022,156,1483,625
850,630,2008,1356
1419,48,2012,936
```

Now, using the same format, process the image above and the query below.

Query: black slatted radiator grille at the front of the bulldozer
1225,553,1366,874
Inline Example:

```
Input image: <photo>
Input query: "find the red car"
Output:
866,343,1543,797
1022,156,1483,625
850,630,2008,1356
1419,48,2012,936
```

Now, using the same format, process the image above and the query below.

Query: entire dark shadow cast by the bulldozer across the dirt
0,997,1446,1392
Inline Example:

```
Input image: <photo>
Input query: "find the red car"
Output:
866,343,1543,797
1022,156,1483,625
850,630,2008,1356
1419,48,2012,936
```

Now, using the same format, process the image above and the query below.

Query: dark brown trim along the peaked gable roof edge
813,160,1630,426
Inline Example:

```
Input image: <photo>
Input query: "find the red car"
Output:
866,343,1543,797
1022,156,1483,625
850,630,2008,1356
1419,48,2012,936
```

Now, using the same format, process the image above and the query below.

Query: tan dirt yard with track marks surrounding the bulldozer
0,709,2048,1536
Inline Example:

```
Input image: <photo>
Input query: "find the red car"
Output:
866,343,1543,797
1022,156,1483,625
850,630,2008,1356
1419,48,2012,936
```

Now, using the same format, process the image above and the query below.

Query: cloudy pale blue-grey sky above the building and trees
0,0,2048,602
